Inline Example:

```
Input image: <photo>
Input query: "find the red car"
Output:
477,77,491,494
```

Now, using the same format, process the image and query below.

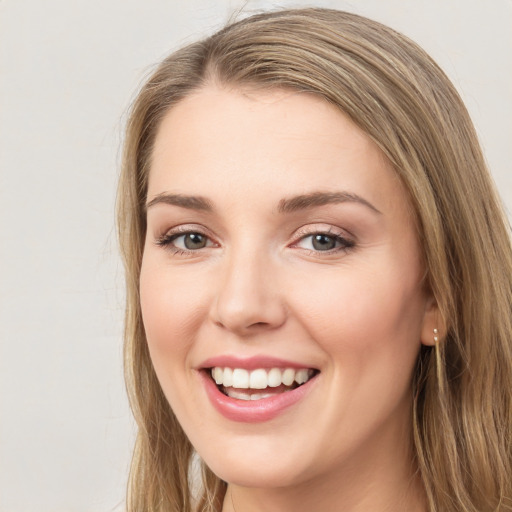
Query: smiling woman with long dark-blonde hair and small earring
119,9,512,512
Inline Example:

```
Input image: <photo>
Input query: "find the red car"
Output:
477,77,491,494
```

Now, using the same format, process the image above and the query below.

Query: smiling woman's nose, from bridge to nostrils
211,248,287,337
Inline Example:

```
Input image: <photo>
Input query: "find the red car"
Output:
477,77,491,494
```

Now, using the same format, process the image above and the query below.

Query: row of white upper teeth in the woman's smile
211,366,314,389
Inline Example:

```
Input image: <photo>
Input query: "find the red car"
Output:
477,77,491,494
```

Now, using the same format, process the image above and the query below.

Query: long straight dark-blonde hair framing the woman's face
118,9,512,512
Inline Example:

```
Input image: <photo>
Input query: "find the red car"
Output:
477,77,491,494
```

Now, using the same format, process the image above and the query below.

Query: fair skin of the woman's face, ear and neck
140,85,437,512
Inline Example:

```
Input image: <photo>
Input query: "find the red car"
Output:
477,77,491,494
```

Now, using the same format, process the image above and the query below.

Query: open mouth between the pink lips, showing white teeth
205,366,319,401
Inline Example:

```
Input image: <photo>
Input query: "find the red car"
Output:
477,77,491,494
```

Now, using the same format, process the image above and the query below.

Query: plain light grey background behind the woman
0,0,512,512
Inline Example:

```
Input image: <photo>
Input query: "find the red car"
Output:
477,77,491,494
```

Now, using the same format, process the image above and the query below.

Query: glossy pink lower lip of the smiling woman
200,371,316,423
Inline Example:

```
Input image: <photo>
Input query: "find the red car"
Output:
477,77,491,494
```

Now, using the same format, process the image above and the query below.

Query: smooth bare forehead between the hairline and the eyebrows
148,86,407,216
